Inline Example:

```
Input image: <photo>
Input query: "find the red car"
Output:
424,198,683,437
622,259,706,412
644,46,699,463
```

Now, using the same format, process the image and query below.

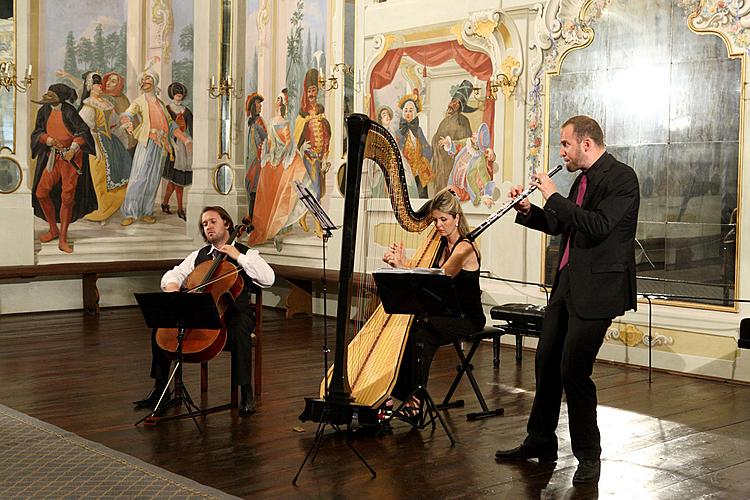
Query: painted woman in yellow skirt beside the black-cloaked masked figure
78,71,133,222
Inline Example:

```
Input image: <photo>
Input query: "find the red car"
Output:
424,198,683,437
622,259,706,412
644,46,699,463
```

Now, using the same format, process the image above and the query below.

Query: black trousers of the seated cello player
151,309,255,385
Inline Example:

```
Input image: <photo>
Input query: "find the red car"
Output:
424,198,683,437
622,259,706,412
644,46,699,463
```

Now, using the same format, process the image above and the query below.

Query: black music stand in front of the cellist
134,292,223,432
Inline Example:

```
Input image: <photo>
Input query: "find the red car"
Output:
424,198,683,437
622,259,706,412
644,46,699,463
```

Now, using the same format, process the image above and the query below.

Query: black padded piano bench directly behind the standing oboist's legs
490,304,546,368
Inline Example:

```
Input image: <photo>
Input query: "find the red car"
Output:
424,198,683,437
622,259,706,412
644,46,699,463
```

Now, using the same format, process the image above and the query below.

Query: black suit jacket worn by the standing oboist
516,152,640,319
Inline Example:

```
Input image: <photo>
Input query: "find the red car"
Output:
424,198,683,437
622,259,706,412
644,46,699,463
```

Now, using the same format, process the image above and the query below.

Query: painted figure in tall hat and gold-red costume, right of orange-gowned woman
294,69,331,236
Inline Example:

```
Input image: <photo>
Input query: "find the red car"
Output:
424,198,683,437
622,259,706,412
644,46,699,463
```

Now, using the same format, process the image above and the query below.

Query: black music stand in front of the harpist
372,269,461,446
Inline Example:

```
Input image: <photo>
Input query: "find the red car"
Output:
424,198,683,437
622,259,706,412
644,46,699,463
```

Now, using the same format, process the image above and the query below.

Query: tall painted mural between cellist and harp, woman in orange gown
245,0,331,251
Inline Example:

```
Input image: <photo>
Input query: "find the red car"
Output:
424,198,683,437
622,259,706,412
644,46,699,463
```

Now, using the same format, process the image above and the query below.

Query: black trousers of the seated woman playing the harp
392,316,481,401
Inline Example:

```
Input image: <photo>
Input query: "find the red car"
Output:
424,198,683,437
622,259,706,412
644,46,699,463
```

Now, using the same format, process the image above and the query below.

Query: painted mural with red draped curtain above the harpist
369,41,500,207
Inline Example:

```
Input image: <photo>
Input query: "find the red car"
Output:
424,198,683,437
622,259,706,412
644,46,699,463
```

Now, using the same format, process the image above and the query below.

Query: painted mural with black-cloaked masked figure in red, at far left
30,0,193,253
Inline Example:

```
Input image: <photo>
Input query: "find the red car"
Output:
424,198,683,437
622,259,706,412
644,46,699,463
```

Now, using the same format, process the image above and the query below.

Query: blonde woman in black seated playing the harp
383,189,486,406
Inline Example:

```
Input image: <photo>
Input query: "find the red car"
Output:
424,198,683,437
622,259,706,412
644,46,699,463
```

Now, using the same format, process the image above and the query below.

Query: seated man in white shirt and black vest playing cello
133,207,275,417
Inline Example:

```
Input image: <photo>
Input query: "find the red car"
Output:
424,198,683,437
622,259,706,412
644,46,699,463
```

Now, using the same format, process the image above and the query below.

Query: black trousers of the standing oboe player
524,267,612,460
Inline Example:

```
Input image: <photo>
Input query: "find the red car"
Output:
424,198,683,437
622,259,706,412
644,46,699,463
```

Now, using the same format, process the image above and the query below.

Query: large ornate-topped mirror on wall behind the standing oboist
545,0,744,307
